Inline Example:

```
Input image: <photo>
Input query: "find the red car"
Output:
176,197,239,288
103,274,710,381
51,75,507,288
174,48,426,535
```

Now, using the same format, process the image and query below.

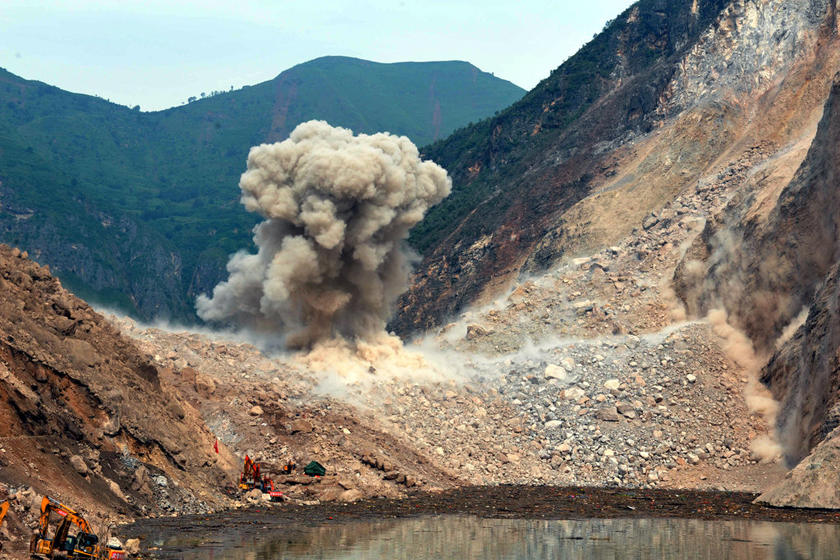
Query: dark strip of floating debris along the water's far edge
122,486,840,546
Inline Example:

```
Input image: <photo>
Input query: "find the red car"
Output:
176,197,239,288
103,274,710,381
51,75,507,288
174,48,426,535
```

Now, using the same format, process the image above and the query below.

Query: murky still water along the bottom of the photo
154,516,840,560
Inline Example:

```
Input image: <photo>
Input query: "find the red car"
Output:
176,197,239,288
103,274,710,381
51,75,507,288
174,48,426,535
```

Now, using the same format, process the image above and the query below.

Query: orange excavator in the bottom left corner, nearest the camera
29,496,126,560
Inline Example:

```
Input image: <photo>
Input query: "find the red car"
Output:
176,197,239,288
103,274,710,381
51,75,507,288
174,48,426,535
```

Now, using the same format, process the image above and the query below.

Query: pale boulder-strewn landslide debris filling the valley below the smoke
113,164,783,506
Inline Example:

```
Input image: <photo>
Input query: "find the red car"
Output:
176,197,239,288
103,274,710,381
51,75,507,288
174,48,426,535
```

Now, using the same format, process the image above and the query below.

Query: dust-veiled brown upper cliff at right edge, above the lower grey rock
676,71,840,352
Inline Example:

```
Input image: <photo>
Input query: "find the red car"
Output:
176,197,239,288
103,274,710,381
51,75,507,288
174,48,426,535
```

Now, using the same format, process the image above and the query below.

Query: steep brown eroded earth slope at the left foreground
0,245,235,516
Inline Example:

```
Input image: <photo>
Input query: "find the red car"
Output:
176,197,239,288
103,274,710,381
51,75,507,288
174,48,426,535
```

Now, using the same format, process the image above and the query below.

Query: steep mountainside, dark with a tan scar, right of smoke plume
393,0,835,333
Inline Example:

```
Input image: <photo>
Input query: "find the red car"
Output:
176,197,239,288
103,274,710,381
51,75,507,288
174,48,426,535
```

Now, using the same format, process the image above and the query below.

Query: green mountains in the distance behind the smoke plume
0,57,524,320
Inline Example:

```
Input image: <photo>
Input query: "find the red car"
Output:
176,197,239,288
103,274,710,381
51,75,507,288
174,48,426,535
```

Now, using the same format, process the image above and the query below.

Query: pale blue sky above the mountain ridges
0,0,632,110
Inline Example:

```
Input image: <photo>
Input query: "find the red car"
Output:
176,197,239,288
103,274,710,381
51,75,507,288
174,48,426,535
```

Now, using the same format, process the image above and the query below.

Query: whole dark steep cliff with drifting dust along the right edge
675,75,840,470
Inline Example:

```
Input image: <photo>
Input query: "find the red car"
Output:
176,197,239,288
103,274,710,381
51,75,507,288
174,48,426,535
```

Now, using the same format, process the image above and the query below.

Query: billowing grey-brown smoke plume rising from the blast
197,121,452,347
